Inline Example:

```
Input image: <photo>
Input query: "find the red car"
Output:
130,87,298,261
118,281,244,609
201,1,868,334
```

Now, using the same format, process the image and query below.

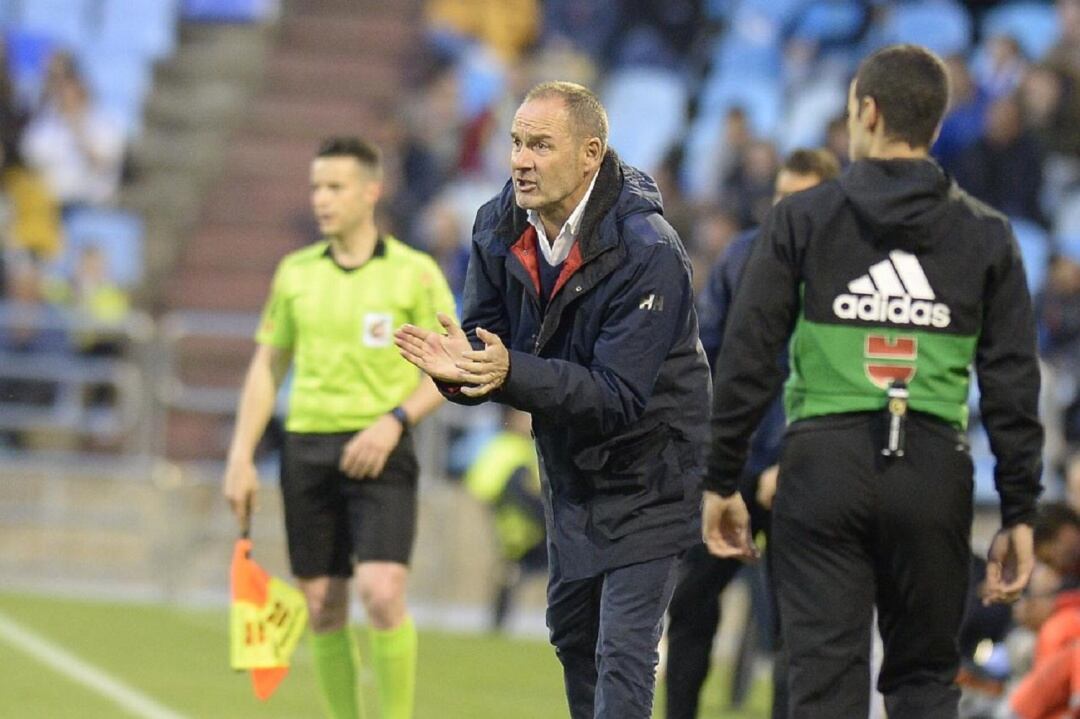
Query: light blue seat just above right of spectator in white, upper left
79,48,152,136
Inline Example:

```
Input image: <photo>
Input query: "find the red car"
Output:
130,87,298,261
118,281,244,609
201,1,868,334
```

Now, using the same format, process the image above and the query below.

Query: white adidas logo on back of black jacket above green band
833,249,951,328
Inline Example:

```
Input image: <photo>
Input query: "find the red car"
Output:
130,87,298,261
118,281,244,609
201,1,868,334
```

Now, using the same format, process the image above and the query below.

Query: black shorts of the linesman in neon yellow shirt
281,432,419,578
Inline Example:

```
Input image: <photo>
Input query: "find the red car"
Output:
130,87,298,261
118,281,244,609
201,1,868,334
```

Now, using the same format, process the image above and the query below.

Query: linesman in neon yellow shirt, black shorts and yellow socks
224,137,454,719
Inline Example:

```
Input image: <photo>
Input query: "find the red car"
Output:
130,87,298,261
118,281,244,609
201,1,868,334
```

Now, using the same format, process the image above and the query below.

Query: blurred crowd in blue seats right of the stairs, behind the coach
387,0,1080,490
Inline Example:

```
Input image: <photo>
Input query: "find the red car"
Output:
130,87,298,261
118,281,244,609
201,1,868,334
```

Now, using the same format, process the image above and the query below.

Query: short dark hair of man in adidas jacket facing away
855,45,948,148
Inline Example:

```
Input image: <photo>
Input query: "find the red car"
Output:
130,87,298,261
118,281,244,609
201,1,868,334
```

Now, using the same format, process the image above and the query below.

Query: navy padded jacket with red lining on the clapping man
446,151,712,580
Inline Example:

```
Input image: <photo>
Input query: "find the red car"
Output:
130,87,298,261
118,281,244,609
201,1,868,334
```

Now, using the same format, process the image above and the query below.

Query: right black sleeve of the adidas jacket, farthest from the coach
975,226,1042,527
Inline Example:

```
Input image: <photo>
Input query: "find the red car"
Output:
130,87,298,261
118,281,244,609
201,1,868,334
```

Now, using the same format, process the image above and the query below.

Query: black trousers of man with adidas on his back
772,413,972,719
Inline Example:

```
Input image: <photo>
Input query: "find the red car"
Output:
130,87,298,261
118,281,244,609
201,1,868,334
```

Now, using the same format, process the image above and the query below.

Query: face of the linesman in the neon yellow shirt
311,157,379,238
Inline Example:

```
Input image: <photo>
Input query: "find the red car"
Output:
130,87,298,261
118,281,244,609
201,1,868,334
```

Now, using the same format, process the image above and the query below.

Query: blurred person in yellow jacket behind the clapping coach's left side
464,407,548,630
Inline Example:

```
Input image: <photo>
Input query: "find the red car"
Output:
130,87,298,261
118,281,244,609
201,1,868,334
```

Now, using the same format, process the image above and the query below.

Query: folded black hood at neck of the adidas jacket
840,160,953,250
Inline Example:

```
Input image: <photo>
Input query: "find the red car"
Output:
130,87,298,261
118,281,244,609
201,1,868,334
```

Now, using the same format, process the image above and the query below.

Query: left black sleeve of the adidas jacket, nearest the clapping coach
705,202,801,497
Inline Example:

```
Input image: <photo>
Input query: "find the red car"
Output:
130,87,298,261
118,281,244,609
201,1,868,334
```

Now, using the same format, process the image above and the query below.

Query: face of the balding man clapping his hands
510,97,599,216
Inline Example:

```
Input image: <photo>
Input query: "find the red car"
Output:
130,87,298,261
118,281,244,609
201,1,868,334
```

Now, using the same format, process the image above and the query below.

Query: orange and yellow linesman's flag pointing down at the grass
229,537,308,700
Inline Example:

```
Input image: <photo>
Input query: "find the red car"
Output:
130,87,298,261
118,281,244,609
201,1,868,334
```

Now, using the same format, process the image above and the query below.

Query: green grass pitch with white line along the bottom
0,594,767,719
